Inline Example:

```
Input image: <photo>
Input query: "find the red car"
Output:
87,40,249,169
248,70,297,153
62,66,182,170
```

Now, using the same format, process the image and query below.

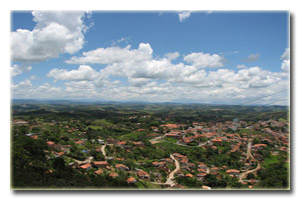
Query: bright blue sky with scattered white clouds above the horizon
10,11,290,105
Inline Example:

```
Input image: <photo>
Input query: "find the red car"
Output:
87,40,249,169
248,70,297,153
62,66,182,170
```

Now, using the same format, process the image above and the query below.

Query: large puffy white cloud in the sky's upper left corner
10,11,88,62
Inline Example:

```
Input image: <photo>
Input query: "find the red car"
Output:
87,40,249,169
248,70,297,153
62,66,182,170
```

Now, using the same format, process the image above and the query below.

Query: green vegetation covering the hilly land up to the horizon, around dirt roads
11,102,289,189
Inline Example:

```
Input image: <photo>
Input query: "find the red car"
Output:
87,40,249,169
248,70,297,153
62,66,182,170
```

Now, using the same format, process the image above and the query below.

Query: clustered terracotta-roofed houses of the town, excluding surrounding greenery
19,116,289,187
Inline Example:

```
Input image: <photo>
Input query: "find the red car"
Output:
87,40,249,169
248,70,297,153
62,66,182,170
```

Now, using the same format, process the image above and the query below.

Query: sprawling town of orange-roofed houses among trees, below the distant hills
12,102,290,190
